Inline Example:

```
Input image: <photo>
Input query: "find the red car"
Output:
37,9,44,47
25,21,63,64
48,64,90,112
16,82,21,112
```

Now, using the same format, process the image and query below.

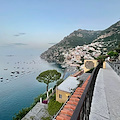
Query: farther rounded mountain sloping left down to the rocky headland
41,29,101,64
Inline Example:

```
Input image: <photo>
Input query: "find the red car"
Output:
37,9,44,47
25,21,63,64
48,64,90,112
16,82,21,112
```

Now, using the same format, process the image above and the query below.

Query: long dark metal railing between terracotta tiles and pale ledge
71,63,102,120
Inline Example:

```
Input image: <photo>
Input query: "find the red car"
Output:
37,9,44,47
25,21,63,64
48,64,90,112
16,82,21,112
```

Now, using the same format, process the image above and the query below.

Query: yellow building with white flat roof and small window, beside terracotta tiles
56,71,90,103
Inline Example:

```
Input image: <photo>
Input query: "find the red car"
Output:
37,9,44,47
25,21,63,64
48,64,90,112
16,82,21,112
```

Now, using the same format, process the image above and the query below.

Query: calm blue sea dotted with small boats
0,48,63,120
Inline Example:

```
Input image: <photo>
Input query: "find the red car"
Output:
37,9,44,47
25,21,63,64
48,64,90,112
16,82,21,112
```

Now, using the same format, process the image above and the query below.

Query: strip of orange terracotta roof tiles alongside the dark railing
56,75,90,120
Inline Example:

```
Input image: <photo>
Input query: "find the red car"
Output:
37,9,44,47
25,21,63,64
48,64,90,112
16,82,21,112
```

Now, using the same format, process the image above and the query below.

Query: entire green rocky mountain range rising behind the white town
41,21,120,64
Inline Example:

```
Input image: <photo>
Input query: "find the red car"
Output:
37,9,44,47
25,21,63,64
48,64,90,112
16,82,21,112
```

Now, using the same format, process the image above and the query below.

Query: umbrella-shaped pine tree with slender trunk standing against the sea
36,70,61,97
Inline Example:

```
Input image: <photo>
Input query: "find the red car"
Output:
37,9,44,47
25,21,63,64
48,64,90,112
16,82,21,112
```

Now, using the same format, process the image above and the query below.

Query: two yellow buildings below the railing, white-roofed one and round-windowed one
56,60,98,103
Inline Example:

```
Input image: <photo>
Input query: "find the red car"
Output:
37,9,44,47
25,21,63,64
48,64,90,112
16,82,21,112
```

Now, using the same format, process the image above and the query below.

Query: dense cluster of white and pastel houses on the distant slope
62,42,104,66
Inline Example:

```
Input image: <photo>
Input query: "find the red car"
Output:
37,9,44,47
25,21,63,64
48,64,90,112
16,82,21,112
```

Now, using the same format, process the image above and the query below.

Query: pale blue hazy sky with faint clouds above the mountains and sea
0,0,120,48
